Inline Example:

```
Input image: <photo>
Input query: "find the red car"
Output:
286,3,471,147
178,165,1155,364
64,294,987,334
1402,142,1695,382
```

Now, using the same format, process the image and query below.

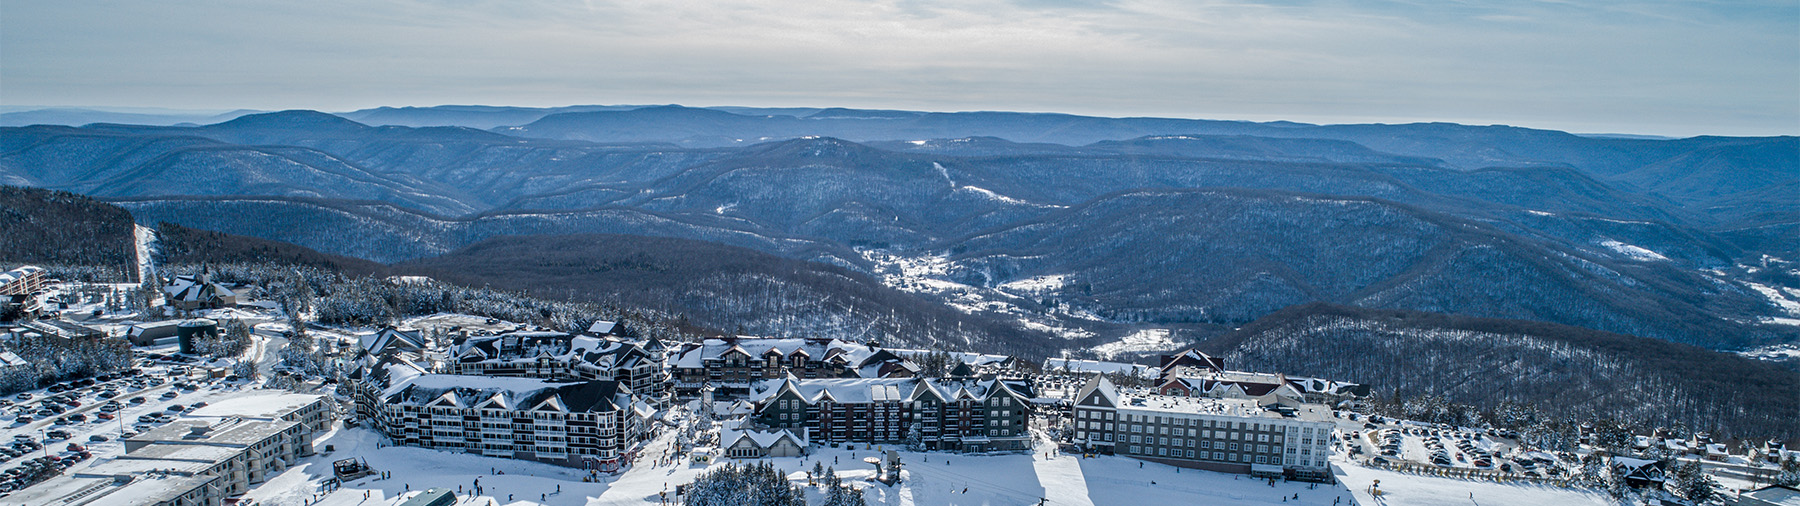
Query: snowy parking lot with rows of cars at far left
0,353,259,497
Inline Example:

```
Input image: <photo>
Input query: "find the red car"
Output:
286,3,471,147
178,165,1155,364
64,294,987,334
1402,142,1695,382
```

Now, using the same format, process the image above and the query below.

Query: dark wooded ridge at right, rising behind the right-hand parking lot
1202,304,1800,439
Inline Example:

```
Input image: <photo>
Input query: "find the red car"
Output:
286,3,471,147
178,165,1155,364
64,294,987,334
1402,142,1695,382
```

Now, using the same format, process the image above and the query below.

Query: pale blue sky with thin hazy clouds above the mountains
0,0,1800,137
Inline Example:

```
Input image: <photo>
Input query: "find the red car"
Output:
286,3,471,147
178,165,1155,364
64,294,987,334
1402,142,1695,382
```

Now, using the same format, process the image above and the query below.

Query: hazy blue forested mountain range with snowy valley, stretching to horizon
0,106,1800,355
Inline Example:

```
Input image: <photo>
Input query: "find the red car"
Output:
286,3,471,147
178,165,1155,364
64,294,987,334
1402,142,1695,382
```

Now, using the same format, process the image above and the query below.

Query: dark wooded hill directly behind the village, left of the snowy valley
394,234,1053,357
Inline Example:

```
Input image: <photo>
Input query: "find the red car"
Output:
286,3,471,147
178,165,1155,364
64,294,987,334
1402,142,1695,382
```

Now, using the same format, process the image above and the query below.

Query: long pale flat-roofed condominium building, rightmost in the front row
1075,376,1332,481
